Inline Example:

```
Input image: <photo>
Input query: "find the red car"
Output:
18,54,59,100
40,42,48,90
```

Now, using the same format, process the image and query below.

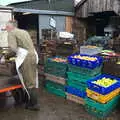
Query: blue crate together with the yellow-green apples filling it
87,74,120,95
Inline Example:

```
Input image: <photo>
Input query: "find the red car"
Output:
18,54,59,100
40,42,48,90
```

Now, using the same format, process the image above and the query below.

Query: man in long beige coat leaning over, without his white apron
6,21,39,110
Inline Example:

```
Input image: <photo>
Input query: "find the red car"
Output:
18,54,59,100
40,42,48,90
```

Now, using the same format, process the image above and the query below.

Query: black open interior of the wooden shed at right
87,11,120,36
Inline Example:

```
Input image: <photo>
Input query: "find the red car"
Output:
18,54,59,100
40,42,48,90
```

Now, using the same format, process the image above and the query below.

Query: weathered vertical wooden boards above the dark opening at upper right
76,0,120,17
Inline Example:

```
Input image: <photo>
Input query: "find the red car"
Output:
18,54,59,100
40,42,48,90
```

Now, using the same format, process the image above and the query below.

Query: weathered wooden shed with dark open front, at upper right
75,0,120,43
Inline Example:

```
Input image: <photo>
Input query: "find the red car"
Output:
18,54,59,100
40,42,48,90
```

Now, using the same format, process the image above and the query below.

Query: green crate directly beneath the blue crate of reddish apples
68,64,102,77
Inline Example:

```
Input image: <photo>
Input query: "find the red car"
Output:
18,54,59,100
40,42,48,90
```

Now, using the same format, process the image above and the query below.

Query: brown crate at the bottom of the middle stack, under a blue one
66,93,85,105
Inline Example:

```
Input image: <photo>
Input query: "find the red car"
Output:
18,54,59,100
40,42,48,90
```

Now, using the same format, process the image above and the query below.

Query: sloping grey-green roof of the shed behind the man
10,0,74,12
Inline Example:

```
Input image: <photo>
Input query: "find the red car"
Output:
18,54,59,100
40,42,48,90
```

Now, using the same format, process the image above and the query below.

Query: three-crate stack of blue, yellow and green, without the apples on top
85,74,120,118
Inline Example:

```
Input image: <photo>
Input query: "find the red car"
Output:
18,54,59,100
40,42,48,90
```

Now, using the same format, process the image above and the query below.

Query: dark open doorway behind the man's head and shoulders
14,12,39,44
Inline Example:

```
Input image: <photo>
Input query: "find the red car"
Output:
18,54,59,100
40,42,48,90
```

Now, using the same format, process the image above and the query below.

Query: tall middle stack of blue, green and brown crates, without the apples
66,54,102,104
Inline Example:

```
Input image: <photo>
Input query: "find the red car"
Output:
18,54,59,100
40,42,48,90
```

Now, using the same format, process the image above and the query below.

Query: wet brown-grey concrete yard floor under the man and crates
0,89,120,120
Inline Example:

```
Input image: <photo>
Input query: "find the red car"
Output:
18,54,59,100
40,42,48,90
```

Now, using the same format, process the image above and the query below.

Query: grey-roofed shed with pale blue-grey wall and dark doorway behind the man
9,0,74,44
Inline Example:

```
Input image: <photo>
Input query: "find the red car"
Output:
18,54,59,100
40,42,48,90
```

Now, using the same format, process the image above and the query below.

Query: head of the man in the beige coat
6,20,18,31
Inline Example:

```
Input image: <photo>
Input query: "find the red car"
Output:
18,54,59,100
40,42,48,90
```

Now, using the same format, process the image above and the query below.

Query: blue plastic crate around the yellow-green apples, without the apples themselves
87,74,120,95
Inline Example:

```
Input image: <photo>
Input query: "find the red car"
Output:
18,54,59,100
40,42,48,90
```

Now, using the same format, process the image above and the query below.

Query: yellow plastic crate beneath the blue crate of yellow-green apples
86,88,120,104
